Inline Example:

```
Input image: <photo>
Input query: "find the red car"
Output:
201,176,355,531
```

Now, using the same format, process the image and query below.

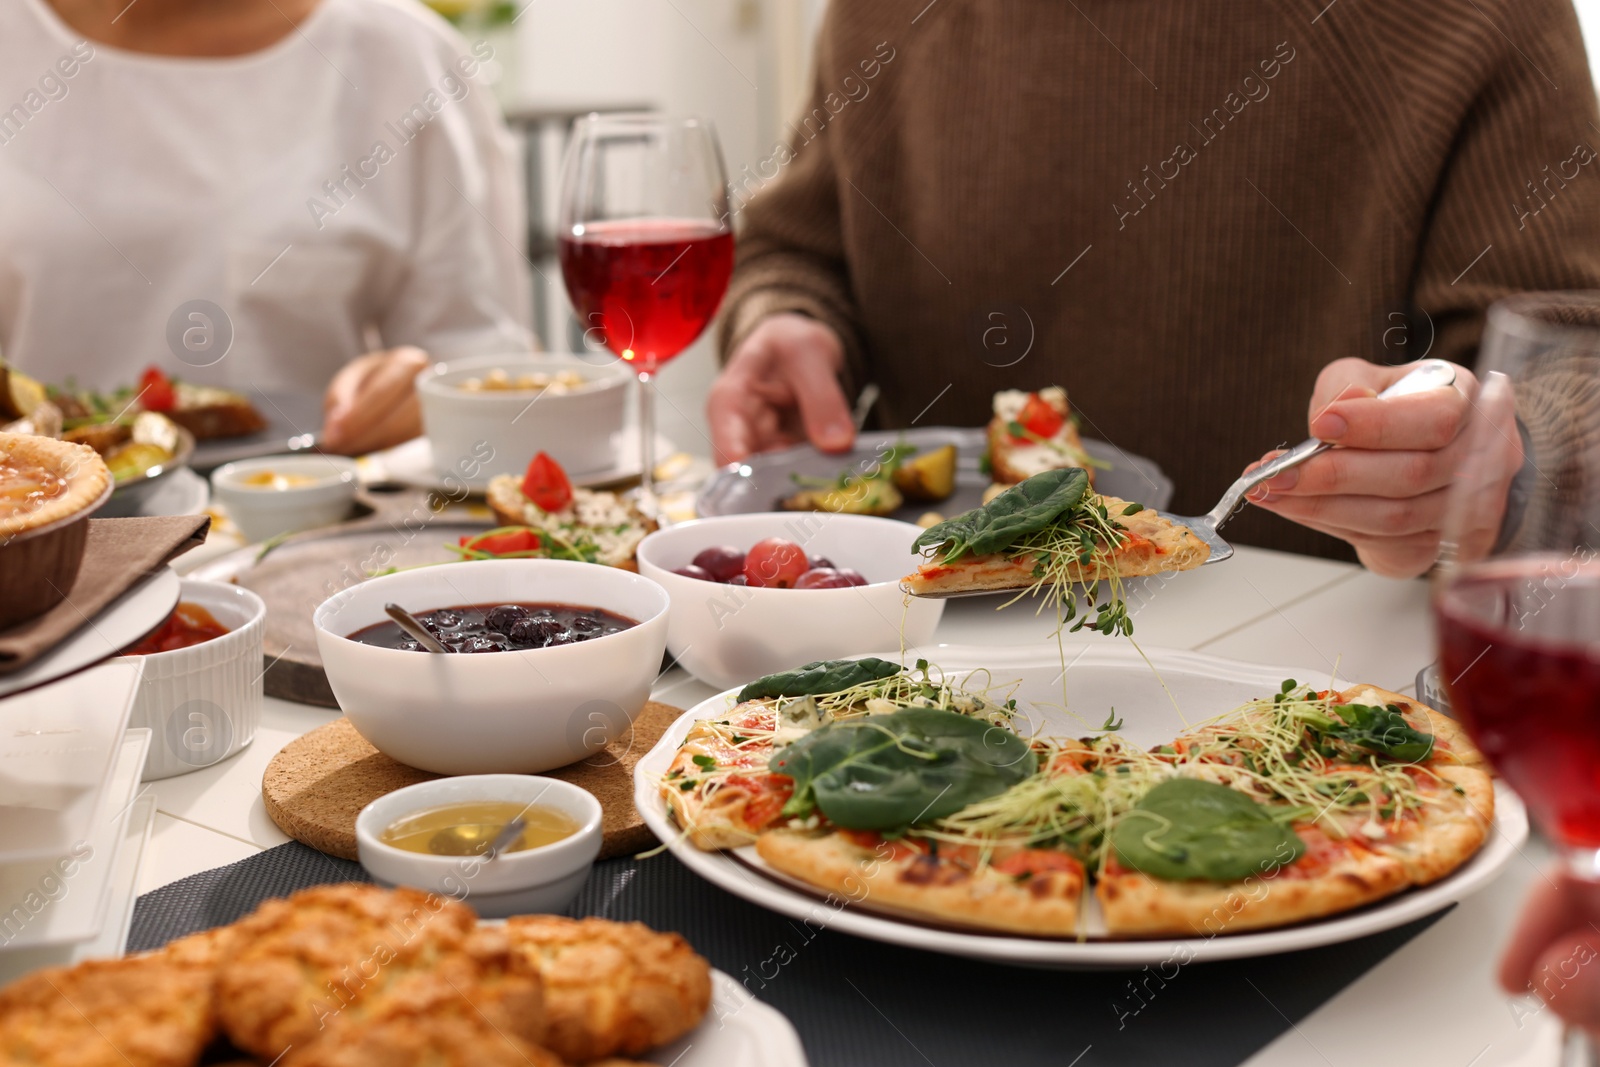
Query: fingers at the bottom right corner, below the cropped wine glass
1499,870,1600,1035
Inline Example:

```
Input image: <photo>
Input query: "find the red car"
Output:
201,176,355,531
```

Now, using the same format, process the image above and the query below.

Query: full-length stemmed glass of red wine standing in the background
557,114,733,514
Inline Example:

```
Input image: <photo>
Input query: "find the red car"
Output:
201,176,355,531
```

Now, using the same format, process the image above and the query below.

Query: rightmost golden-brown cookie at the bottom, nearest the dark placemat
506,915,710,1062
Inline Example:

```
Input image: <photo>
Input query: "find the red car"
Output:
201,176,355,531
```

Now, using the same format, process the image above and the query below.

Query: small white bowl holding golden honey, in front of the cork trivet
355,774,600,918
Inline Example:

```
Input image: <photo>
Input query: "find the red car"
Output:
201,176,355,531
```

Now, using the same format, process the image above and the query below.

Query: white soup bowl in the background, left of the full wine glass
416,355,634,490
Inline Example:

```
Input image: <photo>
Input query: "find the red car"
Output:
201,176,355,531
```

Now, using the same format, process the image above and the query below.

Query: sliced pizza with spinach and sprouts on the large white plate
662,661,1494,937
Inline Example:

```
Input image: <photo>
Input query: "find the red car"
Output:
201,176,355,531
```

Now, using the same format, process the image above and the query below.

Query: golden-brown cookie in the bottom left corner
0,953,216,1067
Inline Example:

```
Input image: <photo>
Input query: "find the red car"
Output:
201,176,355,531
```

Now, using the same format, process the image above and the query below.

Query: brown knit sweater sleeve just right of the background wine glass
717,15,867,395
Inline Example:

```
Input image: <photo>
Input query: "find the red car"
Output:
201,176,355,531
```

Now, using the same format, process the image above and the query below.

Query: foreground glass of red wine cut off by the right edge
1434,293,1600,1062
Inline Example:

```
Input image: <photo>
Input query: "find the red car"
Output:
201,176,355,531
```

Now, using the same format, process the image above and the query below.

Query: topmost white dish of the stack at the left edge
0,661,142,857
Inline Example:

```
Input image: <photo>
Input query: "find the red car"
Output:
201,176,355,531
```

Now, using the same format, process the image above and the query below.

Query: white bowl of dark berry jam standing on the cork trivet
312,560,669,774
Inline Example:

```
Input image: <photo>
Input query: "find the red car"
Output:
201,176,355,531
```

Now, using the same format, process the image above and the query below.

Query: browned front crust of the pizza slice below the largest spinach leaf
755,830,1085,937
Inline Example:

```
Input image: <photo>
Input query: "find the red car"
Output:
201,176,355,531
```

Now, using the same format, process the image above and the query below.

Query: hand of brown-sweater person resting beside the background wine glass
706,312,856,462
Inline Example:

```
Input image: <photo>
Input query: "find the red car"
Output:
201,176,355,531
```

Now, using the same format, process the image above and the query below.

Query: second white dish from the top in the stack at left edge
0,729,150,968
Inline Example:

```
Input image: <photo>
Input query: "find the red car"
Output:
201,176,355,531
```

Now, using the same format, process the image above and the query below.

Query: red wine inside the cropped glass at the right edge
1435,555,1600,848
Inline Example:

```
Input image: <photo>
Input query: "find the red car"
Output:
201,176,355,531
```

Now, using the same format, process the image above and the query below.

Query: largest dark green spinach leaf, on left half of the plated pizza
768,707,1038,830
